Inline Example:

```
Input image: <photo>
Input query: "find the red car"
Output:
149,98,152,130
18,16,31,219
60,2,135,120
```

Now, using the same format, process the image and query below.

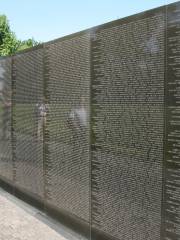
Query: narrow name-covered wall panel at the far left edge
0,58,13,180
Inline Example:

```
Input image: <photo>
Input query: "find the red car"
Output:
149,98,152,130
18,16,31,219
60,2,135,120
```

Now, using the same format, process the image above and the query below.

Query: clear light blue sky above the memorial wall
0,0,176,42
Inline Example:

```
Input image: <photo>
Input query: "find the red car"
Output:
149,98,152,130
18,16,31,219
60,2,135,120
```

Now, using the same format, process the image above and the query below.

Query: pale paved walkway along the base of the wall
0,188,84,240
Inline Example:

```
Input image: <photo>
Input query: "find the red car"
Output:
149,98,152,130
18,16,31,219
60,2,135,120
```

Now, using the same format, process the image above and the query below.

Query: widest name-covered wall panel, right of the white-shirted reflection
92,9,165,240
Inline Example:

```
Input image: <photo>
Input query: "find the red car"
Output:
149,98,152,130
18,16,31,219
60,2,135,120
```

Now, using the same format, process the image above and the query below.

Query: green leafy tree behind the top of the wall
0,15,39,56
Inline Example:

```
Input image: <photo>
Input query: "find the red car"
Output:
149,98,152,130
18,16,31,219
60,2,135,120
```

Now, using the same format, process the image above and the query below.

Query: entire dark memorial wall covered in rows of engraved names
0,2,180,240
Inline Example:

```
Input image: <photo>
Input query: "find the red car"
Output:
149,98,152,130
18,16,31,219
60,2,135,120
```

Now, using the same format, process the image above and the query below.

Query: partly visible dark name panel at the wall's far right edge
163,3,180,240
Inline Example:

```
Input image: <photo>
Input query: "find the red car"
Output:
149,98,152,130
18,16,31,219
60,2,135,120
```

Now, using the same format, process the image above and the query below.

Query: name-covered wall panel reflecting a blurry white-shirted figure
45,34,90,222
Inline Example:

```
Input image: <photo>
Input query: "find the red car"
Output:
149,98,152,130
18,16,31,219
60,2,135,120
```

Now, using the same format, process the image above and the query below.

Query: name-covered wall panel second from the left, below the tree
13,48,44,198
